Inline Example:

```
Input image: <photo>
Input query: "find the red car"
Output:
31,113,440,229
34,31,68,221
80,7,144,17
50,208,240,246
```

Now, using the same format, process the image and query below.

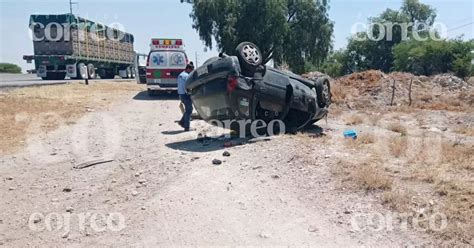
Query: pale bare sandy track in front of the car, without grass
0,85,448,247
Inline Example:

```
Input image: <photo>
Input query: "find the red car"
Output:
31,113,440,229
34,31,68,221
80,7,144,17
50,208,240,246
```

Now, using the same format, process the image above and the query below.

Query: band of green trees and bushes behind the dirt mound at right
319,0,474,79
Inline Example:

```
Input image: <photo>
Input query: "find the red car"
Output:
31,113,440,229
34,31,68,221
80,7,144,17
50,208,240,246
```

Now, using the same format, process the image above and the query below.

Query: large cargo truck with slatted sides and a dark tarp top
23,14,135,80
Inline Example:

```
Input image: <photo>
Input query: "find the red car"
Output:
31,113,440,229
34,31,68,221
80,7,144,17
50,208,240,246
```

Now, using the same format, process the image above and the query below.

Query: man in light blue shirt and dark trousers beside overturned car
178,64,194,132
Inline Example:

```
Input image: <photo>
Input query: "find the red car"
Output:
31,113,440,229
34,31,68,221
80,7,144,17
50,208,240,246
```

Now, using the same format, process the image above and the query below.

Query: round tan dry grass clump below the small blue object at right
352,163,393,191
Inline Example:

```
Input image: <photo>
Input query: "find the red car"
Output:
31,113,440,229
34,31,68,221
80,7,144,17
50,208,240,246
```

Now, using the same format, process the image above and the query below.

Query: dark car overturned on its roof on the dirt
186,42,331,136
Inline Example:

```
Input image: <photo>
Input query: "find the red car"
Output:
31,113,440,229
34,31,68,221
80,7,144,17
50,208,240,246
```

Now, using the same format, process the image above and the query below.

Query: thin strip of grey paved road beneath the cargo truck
0,73,135,88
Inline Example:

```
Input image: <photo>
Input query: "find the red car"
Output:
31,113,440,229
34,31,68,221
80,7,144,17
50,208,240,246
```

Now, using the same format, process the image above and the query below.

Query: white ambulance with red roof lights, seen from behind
146,39,188,96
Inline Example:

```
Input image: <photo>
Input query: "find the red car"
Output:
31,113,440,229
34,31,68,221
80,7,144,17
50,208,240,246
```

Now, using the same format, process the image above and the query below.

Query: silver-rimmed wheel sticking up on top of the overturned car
236,42,263,77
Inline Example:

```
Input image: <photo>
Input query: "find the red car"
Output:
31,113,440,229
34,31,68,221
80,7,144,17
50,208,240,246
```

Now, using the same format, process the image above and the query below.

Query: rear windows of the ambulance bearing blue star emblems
149,51,186,68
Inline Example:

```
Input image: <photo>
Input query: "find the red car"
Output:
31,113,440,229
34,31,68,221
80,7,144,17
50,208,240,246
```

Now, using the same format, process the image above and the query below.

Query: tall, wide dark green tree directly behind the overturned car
190,0,333,72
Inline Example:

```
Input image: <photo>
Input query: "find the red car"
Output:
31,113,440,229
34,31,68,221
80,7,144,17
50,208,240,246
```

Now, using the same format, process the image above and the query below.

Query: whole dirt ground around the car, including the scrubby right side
0,80,474,247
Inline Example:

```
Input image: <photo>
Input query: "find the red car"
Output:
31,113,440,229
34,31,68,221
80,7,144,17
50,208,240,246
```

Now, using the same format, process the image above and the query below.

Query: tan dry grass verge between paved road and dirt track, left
0,82,140,154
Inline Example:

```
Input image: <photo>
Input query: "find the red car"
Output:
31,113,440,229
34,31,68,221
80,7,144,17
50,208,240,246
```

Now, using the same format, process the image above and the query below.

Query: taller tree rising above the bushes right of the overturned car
340,0,436,72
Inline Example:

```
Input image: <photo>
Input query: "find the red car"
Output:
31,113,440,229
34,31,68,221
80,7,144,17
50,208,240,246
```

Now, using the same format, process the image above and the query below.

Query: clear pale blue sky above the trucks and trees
0,0,474,71
